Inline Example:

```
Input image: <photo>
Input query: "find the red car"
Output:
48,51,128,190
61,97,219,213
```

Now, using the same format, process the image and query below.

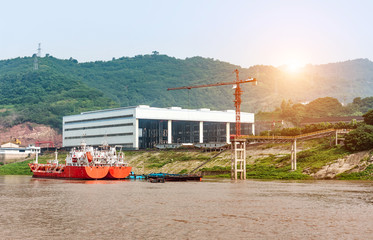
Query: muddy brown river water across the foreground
0,176,373,239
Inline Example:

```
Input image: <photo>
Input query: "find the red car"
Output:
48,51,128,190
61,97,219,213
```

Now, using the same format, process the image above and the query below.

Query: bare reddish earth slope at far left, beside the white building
0,122,62,146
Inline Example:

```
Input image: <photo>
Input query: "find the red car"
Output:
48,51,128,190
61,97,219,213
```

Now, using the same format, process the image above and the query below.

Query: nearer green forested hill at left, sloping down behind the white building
0,65,119,129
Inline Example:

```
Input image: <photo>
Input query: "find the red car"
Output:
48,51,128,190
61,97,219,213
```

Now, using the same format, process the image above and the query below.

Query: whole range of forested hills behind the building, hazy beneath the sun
0,52,373,128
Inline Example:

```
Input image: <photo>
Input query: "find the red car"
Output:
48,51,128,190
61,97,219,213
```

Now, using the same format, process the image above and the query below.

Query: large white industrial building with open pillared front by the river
62,105,255,149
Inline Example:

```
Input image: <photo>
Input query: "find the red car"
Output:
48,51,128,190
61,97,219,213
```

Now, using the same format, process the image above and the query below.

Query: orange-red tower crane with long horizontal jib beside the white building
167,69,257,137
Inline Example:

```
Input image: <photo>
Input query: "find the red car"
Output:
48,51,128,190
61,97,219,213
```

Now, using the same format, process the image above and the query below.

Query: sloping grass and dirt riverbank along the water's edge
0,139,373,180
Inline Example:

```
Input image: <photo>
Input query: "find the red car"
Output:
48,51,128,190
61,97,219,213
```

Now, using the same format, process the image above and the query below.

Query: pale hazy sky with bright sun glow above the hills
0,0,373,67
